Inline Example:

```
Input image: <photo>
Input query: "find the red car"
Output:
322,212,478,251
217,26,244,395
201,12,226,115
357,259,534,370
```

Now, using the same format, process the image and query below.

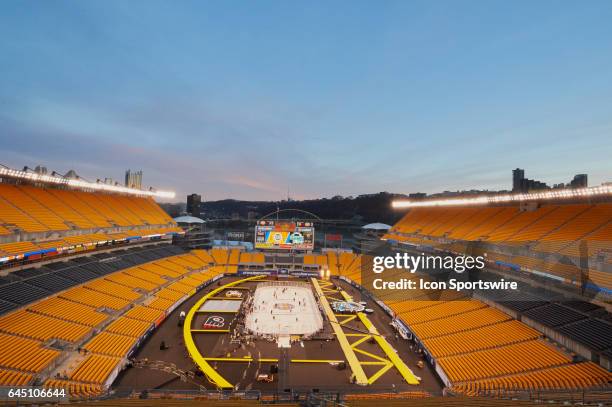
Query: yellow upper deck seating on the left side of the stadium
0,183,182,264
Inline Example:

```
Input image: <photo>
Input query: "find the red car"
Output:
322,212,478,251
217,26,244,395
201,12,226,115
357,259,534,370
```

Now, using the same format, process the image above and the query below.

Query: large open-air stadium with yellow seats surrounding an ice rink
0,164,612,406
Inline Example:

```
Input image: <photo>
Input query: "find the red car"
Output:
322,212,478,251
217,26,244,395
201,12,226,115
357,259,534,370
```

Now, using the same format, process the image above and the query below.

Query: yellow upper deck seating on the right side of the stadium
384,203,612,296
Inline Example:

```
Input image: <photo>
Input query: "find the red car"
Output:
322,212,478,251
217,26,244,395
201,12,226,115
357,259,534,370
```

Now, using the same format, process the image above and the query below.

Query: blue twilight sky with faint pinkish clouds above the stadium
0,0,612,200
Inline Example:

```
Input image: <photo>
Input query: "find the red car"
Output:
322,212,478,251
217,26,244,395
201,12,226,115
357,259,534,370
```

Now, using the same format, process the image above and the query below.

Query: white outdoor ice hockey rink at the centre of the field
245,282,323,337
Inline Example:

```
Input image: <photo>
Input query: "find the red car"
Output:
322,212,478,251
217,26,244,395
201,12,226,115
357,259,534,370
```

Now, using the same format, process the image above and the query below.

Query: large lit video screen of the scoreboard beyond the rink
255,220,314,250
